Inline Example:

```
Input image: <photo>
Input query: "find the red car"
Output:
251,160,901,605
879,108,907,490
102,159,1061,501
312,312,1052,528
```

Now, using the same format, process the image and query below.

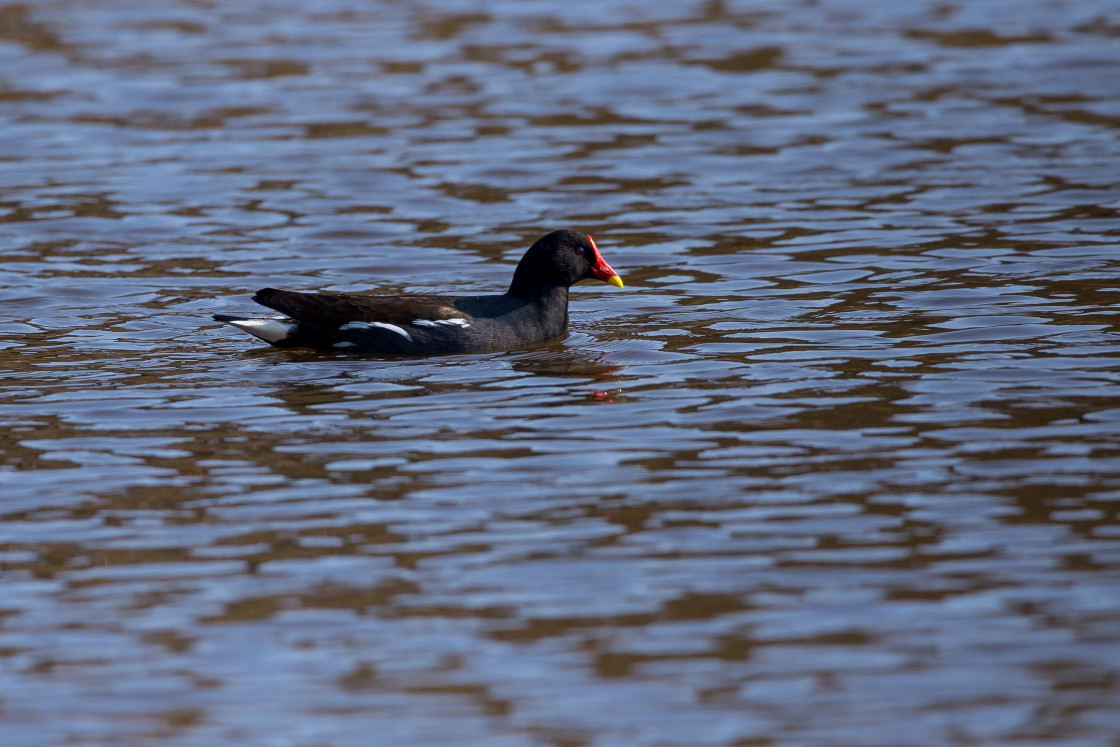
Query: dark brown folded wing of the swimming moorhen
253,288,470,330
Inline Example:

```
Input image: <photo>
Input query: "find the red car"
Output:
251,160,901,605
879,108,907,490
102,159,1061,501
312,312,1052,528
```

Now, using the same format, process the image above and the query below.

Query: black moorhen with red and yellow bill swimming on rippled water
214,230,623,355
